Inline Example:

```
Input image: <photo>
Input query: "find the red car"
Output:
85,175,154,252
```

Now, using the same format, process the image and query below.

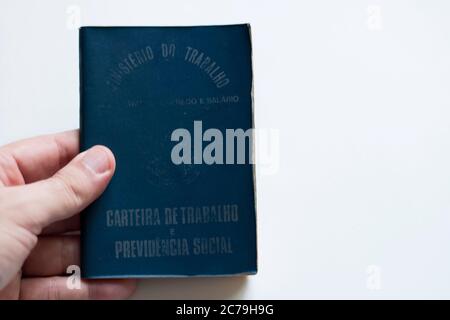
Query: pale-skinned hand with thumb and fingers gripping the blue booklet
0,130,136,299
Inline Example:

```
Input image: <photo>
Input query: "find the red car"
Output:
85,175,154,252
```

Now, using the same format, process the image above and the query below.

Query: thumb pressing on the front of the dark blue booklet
1,146,115,235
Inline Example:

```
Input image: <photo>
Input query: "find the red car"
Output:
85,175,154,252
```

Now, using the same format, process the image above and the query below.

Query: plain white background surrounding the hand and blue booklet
0,0,450,299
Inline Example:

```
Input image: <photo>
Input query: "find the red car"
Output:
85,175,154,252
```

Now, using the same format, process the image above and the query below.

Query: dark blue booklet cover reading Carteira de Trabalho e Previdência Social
80,24,257,278
